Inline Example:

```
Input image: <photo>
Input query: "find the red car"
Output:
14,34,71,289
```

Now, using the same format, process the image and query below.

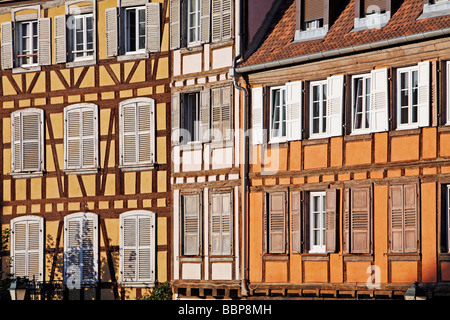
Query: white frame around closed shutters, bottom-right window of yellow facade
119,210,156,287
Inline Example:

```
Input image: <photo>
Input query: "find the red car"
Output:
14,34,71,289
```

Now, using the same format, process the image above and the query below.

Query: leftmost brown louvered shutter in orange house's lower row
267,192,286,253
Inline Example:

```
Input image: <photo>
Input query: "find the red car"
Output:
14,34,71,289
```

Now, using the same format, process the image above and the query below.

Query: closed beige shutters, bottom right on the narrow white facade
210,192,233,256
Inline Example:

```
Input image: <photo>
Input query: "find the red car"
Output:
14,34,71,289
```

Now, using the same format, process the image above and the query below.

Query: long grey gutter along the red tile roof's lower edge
235,28,450,73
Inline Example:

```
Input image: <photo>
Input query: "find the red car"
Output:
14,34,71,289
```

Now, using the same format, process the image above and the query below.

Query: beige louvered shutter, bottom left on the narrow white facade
183,194,201,256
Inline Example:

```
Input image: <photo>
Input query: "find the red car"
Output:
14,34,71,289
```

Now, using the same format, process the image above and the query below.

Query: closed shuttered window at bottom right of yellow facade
120,211,156,285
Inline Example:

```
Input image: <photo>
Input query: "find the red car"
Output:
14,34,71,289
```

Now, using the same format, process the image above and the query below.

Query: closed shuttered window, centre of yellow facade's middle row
64,103,98,172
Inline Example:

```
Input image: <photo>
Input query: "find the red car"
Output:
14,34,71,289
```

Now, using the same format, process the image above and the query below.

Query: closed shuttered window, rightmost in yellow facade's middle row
119,98,156,168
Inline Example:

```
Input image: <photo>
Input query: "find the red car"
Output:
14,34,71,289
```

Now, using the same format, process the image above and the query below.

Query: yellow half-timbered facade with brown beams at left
0,0,172,299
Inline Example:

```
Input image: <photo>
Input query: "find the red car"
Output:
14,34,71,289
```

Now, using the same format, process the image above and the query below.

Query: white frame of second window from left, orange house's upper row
309,80,329,138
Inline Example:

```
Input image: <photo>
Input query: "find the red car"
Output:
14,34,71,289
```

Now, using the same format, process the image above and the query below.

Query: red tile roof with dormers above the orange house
239,0,450,67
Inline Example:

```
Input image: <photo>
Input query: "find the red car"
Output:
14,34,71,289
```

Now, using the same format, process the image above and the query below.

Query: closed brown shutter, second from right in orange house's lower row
350,187,370,253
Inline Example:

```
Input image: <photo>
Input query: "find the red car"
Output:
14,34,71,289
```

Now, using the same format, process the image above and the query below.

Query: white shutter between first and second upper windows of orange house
286,81,303,141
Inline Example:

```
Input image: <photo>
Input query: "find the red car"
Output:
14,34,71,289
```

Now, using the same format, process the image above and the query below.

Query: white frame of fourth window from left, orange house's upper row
396,66,420,129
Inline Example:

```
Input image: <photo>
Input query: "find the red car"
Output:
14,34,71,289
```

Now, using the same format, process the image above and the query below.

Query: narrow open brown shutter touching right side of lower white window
325,189,338,252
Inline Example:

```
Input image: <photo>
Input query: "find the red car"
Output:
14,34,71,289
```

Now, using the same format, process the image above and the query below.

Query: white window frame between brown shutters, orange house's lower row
309,191,326,253
